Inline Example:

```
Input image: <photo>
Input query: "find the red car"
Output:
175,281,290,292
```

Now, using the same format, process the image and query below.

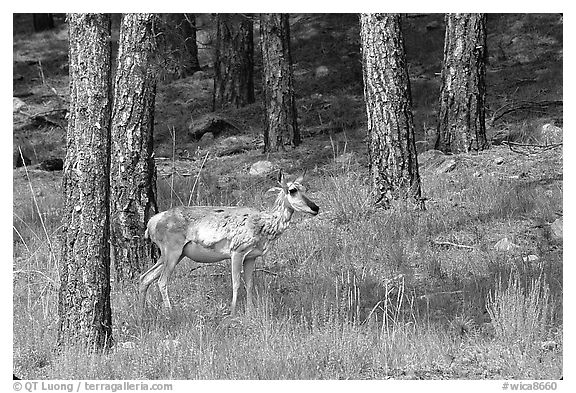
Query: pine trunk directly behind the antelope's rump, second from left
110,14,158,282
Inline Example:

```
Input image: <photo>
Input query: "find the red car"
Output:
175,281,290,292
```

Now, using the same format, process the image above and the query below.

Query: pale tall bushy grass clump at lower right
486,274,554,350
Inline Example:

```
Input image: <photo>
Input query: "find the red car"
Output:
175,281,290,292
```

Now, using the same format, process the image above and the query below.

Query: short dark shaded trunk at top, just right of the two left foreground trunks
163,14,201,78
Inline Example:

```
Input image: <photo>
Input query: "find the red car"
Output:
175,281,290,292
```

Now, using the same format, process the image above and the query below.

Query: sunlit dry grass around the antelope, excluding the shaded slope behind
14,143,562,379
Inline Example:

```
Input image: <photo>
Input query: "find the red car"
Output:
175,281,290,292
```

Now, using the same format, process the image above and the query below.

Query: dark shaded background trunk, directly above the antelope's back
212,14,254,110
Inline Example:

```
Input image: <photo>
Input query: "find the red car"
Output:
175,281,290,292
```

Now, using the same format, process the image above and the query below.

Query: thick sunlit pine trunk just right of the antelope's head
360,14,424,208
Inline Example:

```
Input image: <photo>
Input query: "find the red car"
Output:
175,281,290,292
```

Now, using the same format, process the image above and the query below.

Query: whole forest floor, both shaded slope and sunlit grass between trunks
13,14,563,379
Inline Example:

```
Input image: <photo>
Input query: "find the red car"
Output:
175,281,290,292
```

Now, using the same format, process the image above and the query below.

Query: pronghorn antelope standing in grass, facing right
140,171,320,316
